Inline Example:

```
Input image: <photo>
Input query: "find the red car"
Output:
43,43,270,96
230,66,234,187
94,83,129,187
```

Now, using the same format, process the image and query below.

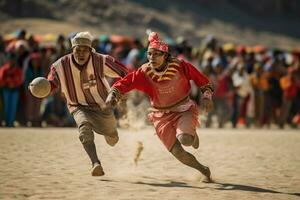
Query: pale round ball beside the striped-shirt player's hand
29,77,51,98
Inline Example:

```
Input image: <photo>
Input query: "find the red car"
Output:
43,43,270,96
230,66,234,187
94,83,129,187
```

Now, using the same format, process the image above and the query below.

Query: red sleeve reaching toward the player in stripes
112,69,147,95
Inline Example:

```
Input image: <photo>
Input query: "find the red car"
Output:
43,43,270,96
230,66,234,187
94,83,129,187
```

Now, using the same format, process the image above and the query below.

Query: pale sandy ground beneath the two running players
0,127,300,200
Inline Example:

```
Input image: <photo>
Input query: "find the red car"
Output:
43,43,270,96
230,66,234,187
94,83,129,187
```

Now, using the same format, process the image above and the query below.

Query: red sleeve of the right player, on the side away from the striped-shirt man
182,61,213,92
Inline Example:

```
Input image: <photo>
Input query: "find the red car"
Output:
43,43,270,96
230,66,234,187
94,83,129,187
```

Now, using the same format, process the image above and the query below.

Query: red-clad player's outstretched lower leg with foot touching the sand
171,140,211,182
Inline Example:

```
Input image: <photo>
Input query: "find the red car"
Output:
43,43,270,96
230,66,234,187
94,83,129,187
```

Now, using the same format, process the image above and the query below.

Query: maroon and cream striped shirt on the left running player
48,53,127,112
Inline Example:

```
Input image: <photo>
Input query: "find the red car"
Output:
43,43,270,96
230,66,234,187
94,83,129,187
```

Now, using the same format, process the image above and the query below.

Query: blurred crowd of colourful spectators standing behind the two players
0,29,300,128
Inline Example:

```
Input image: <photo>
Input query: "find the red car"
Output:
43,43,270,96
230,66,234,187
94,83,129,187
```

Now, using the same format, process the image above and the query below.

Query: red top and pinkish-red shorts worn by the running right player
113,59,209,151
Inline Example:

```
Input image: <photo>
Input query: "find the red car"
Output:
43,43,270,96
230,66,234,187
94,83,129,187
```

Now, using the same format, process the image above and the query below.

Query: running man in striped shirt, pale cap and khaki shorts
48,32,127,176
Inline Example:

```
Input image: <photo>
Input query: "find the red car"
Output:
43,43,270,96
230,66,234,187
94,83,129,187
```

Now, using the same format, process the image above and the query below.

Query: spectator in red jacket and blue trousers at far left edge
0,53,23,127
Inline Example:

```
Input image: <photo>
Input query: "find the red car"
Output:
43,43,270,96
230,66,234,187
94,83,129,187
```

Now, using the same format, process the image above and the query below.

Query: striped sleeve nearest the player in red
104,55,128,78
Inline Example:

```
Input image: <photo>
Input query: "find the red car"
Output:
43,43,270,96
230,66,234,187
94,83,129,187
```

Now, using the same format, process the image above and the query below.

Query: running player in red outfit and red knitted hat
106,32,213,182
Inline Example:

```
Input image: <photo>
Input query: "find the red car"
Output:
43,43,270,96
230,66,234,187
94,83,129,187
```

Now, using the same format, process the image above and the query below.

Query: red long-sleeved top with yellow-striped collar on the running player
113,59,209,108
